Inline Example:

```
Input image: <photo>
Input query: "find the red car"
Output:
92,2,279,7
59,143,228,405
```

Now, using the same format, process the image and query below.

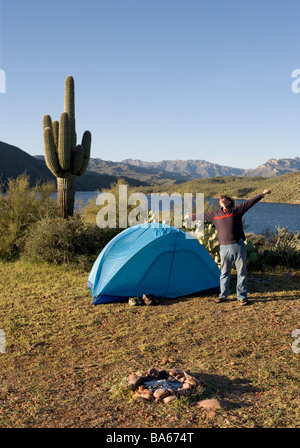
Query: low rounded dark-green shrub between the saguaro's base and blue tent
23,213,112,265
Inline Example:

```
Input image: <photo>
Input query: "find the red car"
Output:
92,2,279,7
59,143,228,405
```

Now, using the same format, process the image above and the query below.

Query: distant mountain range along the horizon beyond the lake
0,142,300,191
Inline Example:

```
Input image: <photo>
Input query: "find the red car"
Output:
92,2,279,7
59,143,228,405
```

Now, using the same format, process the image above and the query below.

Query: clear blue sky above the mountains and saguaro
0,0,300,168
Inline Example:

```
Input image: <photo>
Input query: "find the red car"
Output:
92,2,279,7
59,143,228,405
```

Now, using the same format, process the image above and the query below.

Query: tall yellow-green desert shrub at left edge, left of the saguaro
0,174,57,260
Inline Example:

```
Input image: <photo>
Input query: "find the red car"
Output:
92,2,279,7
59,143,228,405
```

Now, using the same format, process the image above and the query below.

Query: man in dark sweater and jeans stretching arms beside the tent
187,190,271,305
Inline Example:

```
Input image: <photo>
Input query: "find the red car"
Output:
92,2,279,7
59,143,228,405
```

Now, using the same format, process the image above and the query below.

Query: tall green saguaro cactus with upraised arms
43,76,92,218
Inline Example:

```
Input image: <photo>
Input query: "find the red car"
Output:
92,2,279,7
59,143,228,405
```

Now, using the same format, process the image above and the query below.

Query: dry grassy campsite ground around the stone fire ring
0,262,300,428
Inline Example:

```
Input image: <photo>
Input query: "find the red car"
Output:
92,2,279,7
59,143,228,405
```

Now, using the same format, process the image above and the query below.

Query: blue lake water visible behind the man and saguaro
56,191,300,233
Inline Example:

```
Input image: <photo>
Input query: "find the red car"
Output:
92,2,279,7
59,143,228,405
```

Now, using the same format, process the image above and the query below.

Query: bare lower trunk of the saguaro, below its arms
57,172,76,218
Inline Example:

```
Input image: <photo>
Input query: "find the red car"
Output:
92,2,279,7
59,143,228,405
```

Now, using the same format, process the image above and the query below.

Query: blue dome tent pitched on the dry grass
88,223,220,304
